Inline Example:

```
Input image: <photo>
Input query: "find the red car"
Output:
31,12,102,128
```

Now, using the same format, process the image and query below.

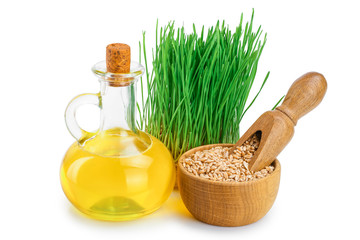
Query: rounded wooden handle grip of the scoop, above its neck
276,72,327,125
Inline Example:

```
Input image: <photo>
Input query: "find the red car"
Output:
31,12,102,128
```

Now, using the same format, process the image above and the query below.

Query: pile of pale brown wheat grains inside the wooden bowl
182,134,274,182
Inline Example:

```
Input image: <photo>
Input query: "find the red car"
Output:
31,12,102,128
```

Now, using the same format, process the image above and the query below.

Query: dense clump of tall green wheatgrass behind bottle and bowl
138,12,270,160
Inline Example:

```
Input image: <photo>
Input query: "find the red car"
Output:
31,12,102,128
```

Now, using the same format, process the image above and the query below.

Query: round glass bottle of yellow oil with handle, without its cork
60,62,175,221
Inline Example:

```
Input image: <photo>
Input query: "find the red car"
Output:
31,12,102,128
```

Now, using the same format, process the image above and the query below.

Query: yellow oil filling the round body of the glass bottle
60,129,175,221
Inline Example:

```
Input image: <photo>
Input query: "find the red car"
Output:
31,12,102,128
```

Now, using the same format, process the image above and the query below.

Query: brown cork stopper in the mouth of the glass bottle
106,43,131,86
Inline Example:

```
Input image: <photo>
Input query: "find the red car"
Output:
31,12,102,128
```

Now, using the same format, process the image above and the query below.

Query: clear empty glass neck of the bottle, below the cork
100,81,137,134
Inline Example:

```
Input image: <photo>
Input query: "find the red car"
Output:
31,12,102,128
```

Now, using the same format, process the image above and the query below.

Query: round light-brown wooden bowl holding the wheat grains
177,144,281,227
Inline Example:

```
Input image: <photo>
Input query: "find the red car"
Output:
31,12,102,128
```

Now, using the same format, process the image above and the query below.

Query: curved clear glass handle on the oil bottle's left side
65,93,100,143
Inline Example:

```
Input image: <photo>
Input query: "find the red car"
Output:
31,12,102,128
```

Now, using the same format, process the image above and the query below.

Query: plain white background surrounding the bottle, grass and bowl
0,0,360,240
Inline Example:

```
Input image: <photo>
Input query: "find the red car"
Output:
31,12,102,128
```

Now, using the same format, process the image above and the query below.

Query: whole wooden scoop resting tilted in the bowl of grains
231,72,327,171
